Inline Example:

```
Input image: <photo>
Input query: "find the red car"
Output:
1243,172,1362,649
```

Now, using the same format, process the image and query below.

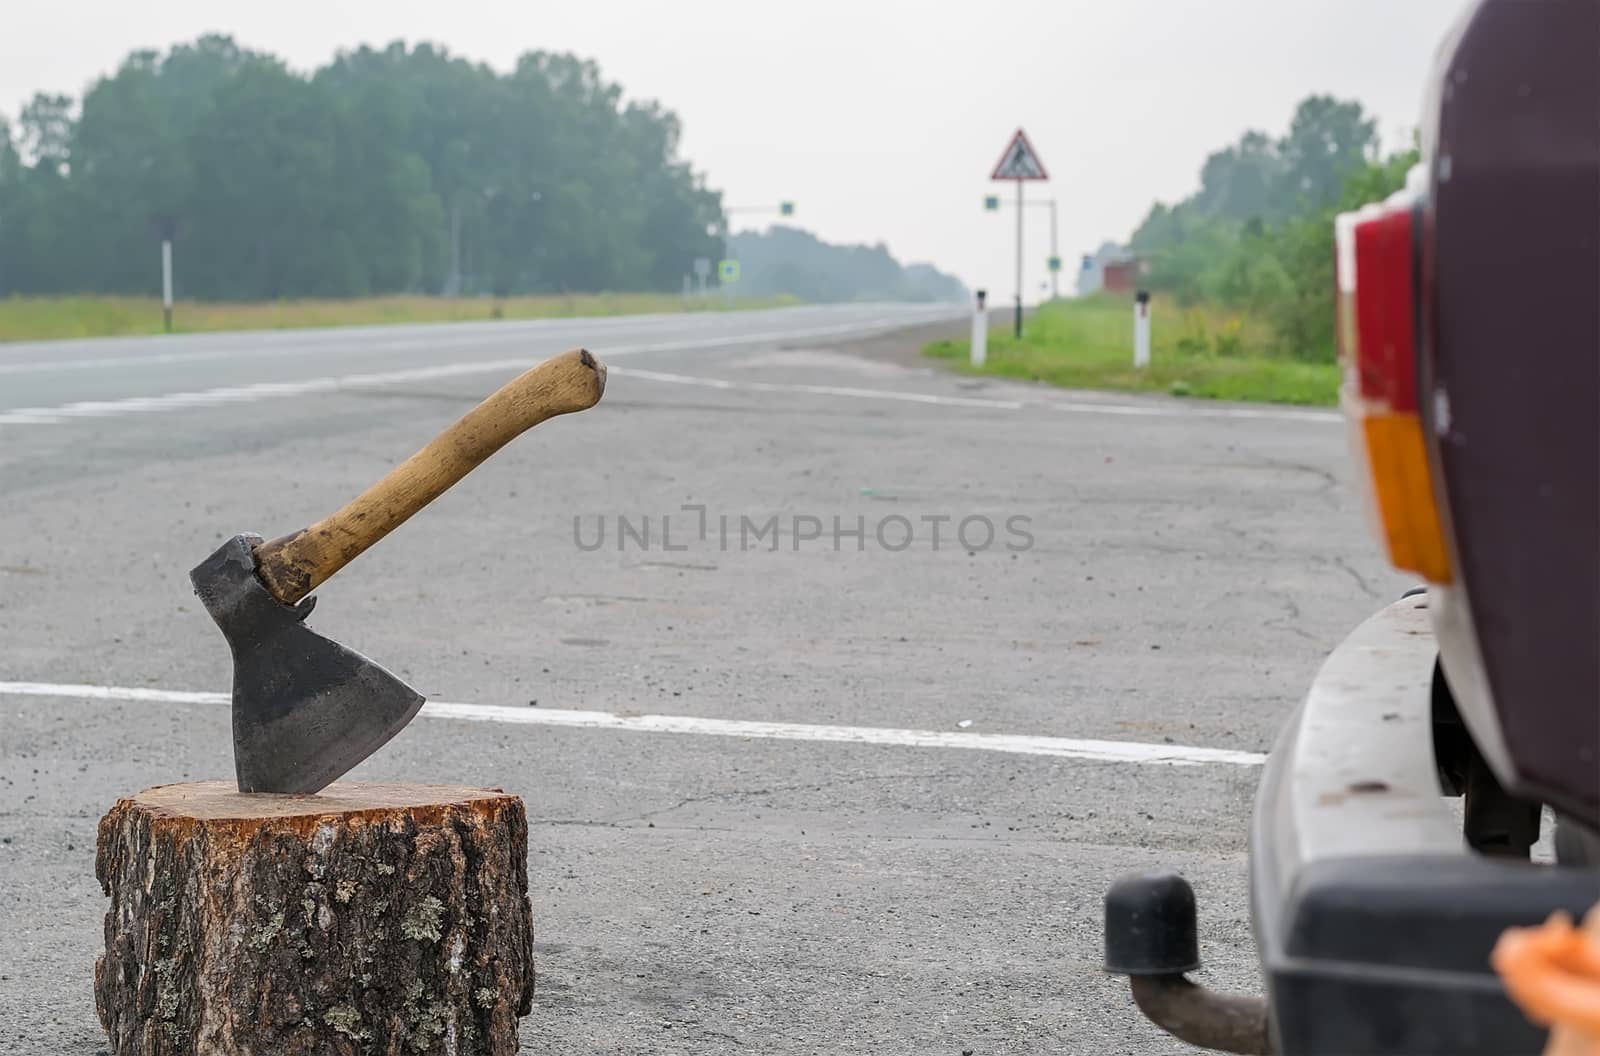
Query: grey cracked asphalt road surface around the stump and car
0,306,1406,1056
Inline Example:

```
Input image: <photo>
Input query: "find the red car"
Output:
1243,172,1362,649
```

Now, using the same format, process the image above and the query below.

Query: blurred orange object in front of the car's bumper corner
1490,906,1600,1056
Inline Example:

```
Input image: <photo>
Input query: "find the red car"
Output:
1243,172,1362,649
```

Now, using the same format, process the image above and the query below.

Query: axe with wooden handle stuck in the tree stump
189,350,605,794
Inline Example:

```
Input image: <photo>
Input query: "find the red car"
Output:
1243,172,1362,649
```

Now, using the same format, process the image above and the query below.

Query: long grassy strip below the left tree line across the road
0,293,794,341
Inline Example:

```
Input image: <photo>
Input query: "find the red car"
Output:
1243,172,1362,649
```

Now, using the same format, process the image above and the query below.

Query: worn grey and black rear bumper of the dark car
1250,597,1600,1056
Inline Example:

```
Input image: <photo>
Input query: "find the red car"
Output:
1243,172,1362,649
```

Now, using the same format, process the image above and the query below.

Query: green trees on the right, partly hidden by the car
1130,96,1418,362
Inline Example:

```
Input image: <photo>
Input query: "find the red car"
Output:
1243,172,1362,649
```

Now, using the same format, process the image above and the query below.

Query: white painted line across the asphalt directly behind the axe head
0,682,1267,766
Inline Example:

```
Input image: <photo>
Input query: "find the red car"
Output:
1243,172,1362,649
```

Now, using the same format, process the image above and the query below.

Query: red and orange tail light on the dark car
1334,168,1451,584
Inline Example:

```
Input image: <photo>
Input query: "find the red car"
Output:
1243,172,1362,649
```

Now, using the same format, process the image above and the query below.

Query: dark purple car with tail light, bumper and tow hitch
1106,0,1600,1056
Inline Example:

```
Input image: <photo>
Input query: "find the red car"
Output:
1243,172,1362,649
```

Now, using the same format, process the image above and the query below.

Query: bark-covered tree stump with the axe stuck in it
94,781,533,1056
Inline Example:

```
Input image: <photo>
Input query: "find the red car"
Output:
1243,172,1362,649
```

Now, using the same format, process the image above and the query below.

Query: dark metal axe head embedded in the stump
189,534,422,794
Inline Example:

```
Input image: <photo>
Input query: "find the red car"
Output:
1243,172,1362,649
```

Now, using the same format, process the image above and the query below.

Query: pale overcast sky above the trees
0,0,1467,299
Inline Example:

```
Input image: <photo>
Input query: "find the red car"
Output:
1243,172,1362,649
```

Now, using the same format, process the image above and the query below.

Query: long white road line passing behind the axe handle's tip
0,318,947,426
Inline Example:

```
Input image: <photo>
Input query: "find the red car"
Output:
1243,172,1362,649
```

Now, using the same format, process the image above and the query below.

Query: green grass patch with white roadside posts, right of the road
926,298,1339,405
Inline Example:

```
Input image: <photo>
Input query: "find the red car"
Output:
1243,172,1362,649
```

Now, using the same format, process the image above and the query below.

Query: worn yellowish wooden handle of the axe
256,349,605,605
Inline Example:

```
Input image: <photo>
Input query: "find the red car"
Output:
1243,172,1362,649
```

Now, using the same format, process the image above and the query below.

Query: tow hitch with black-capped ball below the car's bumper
1106,872,1272,1056
